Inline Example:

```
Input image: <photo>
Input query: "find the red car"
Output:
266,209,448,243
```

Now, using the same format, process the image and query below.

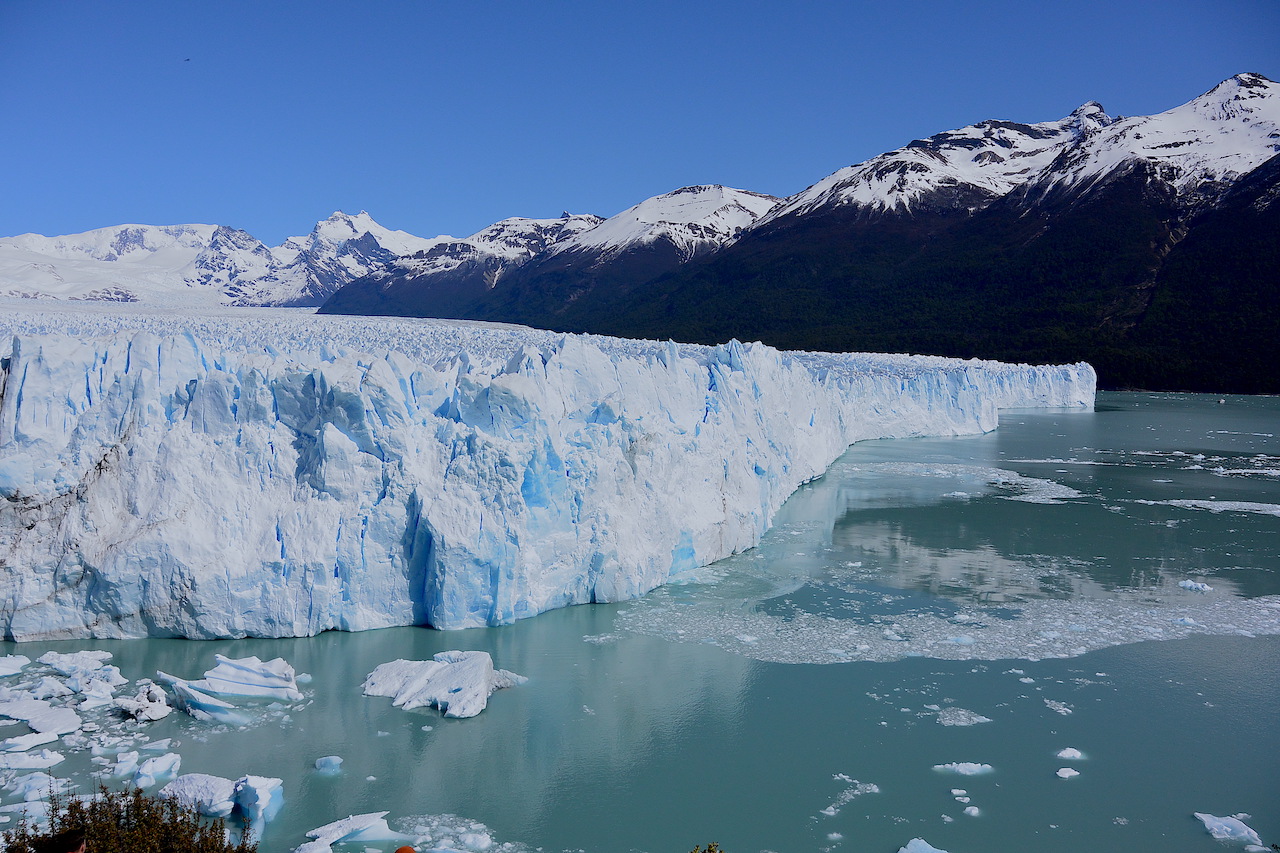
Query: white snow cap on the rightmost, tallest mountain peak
1036,74,1280,201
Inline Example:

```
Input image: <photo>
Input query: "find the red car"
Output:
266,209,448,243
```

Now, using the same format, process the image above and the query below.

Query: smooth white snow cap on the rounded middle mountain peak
554,184,781,260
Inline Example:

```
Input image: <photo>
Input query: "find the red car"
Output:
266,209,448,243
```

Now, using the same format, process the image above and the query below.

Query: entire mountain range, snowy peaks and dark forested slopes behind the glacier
0,73,1280,393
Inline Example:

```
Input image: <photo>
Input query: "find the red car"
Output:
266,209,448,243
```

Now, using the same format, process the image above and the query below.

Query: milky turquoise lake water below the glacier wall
0,393,1280,853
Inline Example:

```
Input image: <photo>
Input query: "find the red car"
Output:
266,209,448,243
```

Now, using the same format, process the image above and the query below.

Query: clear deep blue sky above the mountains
0,0,1280,245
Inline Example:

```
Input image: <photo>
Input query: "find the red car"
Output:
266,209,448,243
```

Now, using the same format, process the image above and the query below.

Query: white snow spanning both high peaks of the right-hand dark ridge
762,74,1280,224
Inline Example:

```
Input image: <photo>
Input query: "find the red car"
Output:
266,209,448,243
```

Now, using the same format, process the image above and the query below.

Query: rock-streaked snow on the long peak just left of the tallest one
769,101,1114,219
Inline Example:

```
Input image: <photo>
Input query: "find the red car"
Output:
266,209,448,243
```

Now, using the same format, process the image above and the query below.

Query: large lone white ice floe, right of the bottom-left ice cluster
364,651,529,717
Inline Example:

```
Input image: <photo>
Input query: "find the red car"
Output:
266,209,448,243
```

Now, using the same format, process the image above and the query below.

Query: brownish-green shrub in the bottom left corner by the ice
4,788,257,853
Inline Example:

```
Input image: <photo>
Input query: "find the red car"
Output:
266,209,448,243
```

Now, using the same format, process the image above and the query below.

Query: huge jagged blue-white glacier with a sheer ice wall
0,306,1096,640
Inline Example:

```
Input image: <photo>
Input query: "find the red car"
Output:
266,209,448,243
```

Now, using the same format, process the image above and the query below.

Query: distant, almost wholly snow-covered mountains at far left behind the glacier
0,211,439,306
